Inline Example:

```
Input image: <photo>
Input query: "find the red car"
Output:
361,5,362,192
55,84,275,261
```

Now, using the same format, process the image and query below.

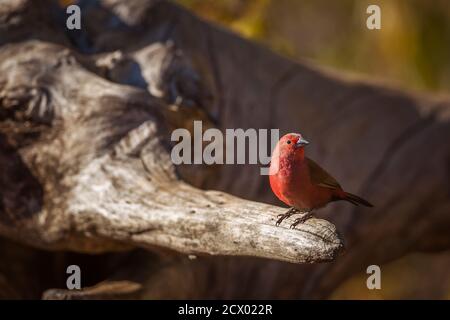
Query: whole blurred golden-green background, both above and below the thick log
178,0,450,299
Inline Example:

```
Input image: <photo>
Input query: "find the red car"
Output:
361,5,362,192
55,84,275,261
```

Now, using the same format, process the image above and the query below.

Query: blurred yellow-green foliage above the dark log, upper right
178,0,450,92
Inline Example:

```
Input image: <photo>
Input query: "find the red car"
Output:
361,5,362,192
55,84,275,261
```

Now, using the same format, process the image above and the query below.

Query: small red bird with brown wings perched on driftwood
269,133,373,228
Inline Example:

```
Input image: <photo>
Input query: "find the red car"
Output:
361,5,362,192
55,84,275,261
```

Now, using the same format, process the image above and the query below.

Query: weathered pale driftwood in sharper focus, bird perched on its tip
0,41,342,263
